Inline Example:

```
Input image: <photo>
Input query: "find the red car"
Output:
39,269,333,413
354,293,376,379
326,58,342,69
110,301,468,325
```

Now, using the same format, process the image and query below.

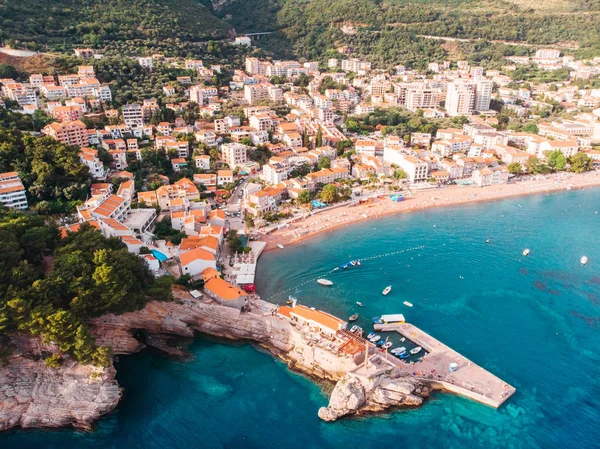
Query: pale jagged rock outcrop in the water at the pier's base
319,373,429,421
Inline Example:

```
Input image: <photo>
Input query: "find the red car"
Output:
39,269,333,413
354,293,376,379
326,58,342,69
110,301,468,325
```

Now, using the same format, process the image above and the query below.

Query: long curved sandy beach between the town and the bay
259,171,600,251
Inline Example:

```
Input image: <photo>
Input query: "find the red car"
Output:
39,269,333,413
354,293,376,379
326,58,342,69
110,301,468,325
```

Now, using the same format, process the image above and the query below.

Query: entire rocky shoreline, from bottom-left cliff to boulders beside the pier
0,292,430,431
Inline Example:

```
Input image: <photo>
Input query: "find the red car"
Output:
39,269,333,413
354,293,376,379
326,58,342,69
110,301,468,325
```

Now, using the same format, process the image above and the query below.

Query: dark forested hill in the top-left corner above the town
0,0,231,50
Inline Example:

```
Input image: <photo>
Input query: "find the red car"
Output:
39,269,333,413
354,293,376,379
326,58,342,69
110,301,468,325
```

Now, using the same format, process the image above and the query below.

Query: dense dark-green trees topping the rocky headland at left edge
0,212,171,366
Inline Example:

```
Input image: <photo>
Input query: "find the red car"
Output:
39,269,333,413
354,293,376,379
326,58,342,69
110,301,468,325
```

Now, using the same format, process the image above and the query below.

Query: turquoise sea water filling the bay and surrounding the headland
0,189,600,449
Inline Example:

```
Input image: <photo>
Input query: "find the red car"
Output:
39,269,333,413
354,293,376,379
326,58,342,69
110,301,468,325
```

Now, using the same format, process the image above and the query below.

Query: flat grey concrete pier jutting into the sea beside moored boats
374,323,515,408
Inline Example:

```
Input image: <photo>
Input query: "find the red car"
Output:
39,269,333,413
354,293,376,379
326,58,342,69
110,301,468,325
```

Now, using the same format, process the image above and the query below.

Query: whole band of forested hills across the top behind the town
0,0,600,67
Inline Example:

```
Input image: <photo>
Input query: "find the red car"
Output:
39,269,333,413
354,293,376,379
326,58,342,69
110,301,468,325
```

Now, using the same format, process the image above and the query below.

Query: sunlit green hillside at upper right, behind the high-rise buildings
215,0,600,65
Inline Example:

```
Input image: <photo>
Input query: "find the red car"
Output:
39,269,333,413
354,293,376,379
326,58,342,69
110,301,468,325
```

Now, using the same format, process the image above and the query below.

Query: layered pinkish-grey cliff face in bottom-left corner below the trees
0,336,121,431
